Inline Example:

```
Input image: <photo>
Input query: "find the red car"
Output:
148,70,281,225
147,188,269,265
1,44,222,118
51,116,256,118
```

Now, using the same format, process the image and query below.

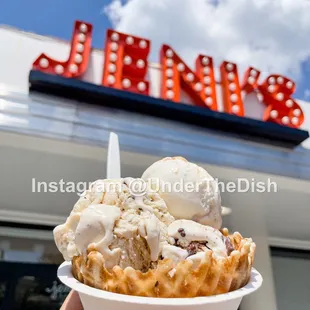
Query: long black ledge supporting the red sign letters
29,70,309,148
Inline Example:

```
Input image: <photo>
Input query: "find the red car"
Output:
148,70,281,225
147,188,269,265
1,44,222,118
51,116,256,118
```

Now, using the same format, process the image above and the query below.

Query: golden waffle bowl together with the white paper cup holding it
58,233,263,310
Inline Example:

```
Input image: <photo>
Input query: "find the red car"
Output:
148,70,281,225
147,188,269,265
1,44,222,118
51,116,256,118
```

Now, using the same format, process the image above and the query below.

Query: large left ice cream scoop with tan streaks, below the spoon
54,178,174,270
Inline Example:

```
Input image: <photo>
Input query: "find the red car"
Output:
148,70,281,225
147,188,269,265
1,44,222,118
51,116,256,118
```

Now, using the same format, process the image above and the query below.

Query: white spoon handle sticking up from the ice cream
107,132,121,179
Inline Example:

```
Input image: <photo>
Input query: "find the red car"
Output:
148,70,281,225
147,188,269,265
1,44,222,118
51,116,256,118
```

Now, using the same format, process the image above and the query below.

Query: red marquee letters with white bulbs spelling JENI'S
33,21,304,128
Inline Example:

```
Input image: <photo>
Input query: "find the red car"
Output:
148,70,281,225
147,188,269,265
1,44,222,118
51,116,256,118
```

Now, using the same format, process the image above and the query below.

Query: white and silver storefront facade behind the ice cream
0,23,310,310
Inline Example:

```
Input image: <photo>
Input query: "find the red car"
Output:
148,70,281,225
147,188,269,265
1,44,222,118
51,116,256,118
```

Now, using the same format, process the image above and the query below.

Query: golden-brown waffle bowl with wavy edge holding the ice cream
72,230,256,298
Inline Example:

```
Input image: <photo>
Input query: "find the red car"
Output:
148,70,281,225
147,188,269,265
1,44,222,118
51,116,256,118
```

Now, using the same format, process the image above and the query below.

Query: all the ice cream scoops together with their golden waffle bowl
54,157,255,297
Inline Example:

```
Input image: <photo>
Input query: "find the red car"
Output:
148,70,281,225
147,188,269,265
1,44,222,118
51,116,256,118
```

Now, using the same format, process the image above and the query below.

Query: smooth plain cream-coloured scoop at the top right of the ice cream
142,157,222,229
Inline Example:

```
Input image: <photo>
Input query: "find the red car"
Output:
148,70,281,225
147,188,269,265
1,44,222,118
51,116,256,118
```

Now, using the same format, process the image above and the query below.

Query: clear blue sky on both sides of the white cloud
0,0,310,100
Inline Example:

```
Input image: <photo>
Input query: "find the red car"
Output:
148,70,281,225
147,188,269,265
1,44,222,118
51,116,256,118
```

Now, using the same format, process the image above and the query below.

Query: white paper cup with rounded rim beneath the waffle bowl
57,262,263,310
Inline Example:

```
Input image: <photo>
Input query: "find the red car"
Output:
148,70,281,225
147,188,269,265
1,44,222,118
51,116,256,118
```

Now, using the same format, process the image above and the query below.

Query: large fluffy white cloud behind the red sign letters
105,0,310,79
